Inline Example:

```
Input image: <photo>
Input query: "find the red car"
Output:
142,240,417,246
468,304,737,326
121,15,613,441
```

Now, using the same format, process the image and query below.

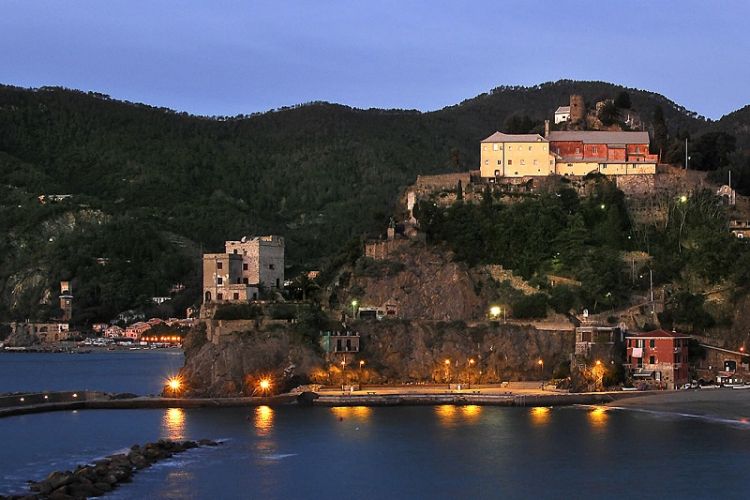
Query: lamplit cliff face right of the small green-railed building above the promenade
334,320,575,383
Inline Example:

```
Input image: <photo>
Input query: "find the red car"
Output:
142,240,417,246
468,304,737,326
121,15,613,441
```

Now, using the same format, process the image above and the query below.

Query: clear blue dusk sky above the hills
0,0,750,119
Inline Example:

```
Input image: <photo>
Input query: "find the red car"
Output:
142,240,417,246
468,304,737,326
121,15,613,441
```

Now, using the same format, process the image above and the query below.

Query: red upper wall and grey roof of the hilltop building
547,130,658,163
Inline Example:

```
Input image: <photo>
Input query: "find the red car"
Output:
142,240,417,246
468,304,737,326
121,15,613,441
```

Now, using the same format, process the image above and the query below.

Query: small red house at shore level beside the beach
626,330,690,389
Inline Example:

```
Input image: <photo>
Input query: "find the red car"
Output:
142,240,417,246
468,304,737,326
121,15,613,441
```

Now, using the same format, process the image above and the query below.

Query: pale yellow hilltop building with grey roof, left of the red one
479,132,555,179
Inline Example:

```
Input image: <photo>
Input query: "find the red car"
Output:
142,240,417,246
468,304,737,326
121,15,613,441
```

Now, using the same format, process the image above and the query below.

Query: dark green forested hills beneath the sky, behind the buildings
0,81,748,320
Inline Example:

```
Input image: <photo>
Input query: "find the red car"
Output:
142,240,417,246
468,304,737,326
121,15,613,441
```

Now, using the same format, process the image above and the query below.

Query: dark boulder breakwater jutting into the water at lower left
0,439,219,500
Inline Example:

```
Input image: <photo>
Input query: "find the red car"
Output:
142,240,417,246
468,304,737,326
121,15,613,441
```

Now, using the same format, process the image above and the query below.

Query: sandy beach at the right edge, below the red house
609,388,750,424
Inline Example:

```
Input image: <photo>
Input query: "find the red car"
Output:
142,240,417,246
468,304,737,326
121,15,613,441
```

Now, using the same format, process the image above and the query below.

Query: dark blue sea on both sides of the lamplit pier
0,352,750,500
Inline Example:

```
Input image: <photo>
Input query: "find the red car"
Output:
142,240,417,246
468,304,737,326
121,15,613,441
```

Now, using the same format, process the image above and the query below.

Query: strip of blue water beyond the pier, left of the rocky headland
0,349,184,394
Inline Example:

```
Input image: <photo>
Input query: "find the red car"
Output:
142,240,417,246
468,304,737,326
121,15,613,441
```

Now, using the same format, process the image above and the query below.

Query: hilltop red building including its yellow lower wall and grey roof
547,130,659,176
